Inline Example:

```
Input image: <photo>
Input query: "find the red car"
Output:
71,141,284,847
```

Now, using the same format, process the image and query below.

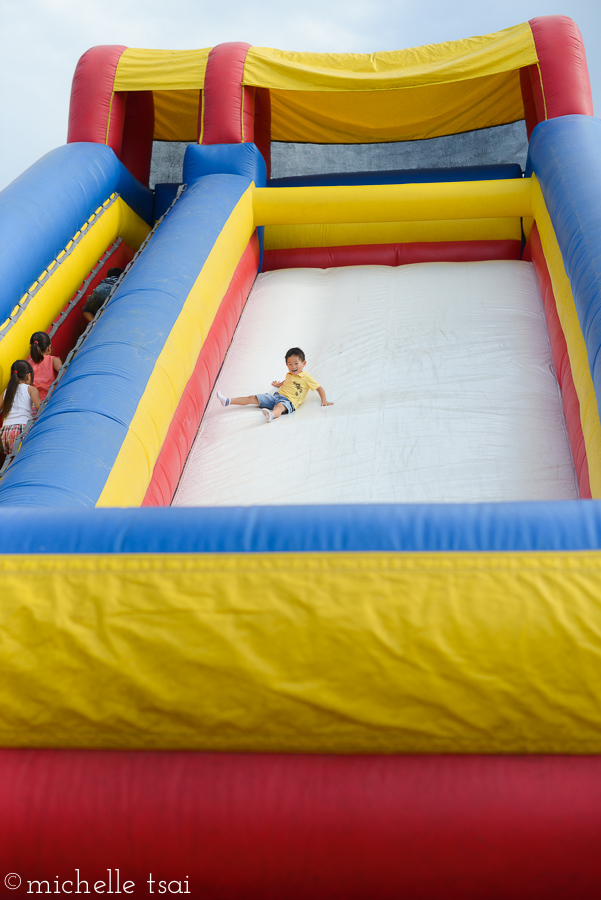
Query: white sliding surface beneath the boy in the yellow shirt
173,261,578,506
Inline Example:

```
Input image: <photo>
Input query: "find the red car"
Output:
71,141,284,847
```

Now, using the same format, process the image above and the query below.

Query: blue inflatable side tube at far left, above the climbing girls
0,144,153,322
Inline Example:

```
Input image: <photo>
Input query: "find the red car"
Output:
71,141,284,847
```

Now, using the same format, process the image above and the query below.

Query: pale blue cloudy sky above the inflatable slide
0,0,601,189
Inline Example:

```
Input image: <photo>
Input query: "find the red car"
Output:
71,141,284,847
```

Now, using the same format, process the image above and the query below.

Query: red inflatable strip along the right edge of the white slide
525,224,591,500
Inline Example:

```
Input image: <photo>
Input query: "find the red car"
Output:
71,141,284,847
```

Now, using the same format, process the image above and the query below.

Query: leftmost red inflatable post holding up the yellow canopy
67,45,127,156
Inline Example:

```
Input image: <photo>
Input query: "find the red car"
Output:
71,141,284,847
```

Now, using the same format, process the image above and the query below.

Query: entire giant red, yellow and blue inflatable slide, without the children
0,16,601,900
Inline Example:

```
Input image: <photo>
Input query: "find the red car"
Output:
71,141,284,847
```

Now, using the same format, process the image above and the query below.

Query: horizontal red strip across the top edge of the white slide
263,240,521,272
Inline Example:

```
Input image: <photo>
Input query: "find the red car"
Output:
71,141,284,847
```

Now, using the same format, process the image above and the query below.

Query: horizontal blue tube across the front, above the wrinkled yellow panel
0,501,601,555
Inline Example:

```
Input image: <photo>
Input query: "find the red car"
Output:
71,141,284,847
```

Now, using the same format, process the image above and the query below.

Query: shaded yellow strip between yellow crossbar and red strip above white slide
265,218,522,250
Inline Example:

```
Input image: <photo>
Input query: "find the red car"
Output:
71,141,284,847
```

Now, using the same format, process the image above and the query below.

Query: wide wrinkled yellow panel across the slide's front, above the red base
0,552,601,754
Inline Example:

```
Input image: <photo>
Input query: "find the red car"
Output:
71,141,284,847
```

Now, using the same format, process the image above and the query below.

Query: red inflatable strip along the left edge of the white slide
142,231,259,506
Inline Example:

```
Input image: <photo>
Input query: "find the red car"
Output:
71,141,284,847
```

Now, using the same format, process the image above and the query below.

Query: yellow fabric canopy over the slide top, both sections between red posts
108,22,537,144
